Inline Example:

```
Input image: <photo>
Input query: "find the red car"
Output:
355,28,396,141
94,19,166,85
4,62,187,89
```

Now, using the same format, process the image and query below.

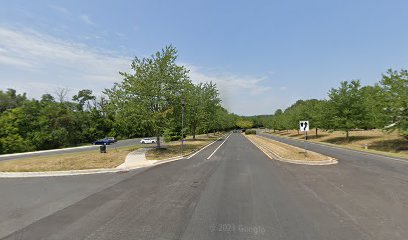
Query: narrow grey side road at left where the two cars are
0,138,151,161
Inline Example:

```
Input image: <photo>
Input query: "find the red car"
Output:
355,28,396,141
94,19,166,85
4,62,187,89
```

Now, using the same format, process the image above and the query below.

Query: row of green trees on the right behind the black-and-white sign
245,69,408,138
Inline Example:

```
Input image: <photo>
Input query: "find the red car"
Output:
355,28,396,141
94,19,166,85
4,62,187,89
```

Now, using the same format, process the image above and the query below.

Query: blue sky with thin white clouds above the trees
0,0,408,115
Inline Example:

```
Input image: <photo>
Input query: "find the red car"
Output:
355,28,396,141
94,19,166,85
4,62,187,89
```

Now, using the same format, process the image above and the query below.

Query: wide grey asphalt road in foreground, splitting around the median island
0,133,408,240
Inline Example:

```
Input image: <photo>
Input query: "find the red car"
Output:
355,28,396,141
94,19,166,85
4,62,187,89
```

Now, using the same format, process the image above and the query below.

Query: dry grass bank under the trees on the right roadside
270,129,408,158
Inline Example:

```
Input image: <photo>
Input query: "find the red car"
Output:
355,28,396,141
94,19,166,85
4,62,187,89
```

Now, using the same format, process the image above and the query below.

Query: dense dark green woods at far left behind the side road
0,89,114,153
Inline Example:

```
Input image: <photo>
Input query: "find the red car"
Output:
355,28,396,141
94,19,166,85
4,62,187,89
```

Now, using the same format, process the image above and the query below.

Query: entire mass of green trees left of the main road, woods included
0,46,238,153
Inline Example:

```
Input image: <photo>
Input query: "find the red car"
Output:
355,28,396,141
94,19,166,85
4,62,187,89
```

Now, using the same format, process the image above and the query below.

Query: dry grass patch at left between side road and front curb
0,146,142,172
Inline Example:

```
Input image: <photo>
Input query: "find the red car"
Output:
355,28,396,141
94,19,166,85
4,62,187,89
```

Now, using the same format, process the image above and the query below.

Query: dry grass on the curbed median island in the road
246,135,329,161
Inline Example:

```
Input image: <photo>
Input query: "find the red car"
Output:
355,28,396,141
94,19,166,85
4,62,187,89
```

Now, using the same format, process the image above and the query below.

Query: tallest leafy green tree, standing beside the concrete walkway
105,45,190,147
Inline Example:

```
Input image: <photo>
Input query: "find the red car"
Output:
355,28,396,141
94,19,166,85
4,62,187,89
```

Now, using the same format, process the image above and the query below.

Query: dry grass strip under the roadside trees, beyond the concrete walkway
146,133,222,160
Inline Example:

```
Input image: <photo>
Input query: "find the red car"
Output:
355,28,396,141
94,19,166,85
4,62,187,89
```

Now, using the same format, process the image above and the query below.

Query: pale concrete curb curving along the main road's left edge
0,135,224,178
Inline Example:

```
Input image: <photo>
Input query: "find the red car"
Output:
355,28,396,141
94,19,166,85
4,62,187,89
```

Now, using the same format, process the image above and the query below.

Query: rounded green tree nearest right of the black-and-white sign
329,80,366,139
